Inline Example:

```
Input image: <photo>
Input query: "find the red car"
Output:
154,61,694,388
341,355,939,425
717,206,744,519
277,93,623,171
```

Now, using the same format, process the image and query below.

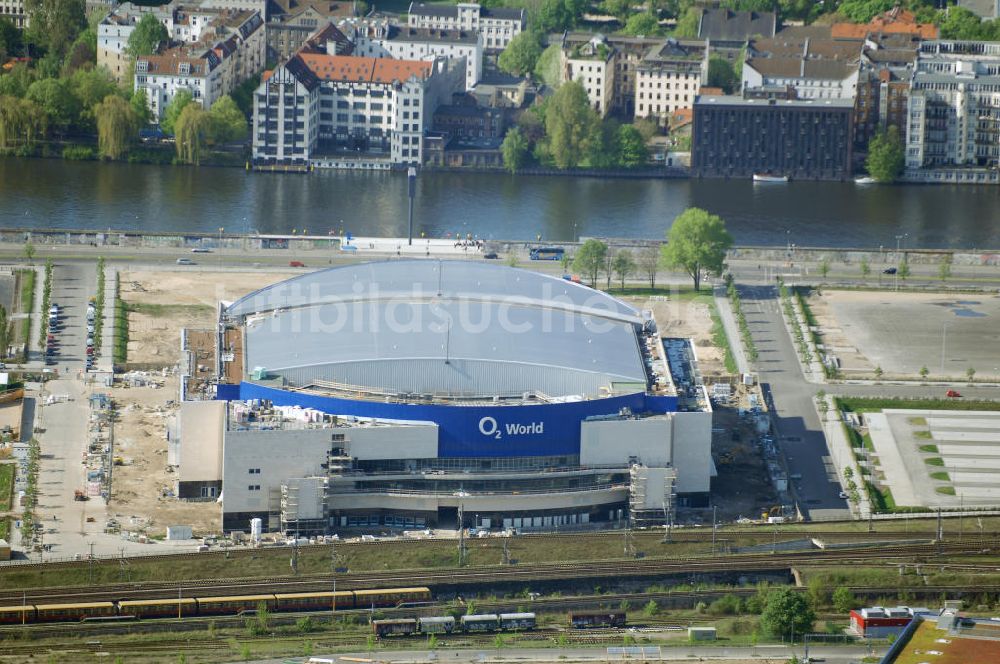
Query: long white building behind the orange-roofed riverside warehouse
340,20,483,90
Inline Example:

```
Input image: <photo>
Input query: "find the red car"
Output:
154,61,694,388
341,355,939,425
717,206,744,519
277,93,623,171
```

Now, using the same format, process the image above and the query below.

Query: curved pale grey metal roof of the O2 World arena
224,260,646,396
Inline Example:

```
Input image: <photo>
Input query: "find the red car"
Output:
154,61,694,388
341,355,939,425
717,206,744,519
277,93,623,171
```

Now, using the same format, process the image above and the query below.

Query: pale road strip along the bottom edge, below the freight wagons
257,637,879,664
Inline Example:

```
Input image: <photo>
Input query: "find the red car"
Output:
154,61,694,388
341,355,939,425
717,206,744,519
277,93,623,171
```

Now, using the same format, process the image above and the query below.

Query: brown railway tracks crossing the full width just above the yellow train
0,540,993,605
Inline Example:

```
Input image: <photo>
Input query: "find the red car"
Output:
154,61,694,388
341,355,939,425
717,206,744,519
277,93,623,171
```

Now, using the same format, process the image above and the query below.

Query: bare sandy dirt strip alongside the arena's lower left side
108,374,222,535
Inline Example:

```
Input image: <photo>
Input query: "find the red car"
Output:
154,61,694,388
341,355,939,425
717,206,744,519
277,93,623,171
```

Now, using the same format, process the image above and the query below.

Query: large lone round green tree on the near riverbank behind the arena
662,208,733,290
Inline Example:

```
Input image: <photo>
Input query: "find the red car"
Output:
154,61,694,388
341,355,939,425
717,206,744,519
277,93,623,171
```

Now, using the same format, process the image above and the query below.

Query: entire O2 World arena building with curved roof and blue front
175,260,715,534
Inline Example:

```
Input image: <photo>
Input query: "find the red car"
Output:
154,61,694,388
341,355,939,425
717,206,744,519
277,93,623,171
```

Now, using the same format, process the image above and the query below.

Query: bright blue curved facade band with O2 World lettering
225,382,677,458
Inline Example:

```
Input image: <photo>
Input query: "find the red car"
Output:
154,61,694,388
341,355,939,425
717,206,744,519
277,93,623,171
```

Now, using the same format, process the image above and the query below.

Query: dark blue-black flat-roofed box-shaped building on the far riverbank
691,88,854,180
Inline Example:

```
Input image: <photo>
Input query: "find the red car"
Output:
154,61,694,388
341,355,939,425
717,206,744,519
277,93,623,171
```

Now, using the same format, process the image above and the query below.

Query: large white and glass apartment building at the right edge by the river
906,40,1000,171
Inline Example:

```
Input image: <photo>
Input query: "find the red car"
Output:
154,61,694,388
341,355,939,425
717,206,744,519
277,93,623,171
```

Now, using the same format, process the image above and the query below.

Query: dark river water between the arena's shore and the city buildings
0,158,1000,249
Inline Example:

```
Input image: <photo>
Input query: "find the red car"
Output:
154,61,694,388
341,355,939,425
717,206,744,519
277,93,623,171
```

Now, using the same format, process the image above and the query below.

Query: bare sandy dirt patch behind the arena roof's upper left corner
120,271,289,366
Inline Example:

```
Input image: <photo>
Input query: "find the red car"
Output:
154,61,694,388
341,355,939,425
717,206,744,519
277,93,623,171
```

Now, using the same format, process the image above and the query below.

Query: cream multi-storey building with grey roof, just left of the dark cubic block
635,39,708,123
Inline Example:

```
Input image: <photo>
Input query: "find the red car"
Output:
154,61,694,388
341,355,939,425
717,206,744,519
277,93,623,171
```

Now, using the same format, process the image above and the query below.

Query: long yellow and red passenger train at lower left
0,588,431,625
